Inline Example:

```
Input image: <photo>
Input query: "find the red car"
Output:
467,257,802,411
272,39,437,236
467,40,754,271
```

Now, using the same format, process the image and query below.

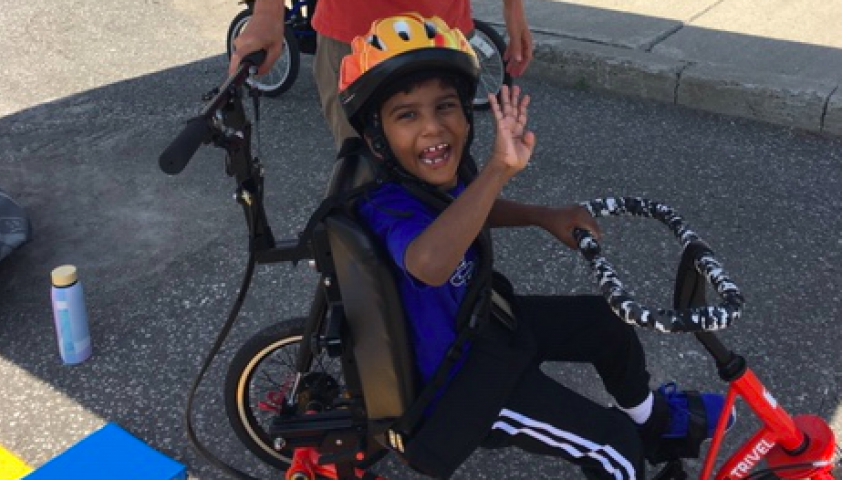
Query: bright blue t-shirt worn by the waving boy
359,183,477,383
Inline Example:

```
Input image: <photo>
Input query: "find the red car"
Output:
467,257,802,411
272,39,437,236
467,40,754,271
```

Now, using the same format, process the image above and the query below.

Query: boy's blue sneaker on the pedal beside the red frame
639,382,737,464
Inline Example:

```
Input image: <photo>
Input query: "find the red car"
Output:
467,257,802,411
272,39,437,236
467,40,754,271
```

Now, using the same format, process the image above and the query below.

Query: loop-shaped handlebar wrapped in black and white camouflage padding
573,197,744,333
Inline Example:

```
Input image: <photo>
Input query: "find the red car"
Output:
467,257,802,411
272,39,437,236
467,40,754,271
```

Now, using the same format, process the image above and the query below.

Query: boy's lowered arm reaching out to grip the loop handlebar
488,198,600,249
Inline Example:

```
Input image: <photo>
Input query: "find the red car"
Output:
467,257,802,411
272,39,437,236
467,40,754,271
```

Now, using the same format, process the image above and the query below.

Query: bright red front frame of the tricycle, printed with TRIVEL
699,369,835,480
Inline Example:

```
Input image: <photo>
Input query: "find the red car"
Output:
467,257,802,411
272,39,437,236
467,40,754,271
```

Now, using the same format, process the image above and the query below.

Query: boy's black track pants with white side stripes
484,296,650,479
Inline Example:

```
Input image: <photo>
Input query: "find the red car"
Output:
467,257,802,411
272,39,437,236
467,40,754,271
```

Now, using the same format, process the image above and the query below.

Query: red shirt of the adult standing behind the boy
313,0,474,43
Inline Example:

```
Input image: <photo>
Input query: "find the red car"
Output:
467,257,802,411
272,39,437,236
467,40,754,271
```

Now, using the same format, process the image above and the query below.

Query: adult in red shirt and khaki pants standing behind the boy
228,0,533,148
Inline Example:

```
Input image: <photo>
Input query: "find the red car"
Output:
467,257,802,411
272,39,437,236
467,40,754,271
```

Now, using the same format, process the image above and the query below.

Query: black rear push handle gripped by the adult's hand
158,50,266,175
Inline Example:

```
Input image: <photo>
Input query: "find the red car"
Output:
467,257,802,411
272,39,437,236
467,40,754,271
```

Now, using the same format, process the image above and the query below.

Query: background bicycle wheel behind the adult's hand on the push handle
227,9,301,97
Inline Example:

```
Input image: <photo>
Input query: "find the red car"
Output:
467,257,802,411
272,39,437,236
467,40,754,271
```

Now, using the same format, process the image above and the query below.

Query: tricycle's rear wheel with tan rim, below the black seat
223,318,344,470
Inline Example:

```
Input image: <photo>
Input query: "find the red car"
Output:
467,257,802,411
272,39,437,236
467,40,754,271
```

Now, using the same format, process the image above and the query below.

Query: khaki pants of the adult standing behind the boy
313,34,359,150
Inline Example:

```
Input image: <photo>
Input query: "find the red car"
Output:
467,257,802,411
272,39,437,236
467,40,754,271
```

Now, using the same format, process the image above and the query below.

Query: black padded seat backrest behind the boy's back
325,141,418,421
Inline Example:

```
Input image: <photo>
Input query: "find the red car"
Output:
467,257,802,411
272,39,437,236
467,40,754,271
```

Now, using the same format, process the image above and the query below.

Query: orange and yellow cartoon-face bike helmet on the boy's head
339,12,479,133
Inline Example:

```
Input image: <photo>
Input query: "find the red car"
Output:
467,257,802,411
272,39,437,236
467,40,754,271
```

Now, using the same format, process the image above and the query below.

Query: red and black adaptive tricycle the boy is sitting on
160,52,838,480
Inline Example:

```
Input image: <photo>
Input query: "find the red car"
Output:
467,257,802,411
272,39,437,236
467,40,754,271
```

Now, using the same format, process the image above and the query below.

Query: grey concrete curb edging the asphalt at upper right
526,32,842,136
